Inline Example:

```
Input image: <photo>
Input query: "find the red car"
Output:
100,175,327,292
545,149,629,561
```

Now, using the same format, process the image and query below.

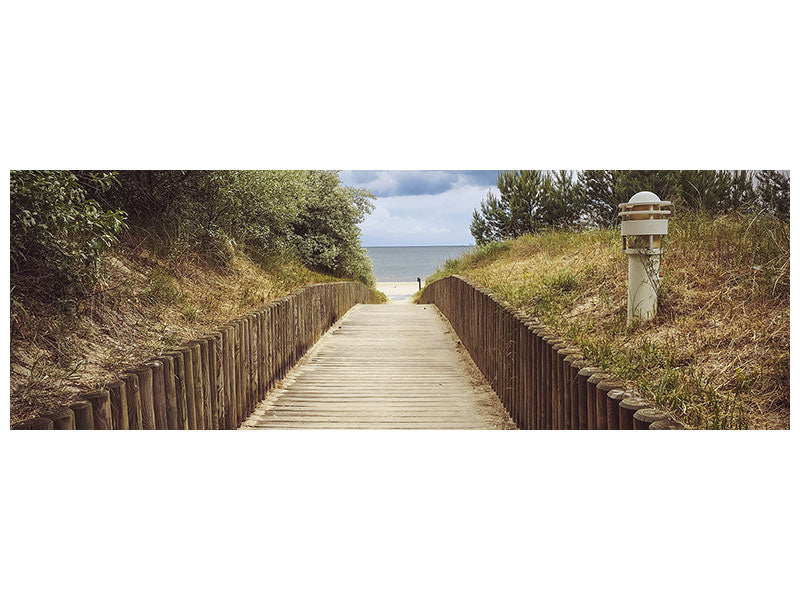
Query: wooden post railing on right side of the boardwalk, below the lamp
421,276,682,429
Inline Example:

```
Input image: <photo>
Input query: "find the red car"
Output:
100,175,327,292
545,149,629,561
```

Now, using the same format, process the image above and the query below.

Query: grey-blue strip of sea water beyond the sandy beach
367,246,473,281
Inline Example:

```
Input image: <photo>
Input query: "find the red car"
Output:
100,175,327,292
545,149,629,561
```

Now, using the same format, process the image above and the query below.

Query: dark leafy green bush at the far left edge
11,171,126,300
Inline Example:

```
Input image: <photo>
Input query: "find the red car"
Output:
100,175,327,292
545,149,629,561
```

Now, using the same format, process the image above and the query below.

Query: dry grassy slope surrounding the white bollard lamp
429,215,789,429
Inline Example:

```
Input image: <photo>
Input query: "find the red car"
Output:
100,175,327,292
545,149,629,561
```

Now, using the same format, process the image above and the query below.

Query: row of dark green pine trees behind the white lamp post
470,170,789,245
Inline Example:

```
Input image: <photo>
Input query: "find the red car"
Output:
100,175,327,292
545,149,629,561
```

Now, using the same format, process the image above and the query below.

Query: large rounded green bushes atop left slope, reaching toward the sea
101,171,375,285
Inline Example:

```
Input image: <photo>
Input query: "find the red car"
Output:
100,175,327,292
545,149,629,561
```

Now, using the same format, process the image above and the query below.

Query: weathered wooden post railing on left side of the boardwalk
14,282,372,429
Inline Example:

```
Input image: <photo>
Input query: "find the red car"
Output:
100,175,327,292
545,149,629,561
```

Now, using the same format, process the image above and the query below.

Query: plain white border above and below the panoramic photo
0,1,798,599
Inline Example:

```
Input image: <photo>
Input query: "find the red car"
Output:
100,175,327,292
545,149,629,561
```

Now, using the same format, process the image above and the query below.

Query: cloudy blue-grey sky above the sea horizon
340,171,497,246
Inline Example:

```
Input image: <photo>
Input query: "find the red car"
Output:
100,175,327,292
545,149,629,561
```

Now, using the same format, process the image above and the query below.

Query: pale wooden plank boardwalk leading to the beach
242,304,515,429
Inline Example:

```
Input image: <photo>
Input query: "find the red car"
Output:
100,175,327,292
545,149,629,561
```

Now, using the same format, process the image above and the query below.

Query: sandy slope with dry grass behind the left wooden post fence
11,234,384,423
